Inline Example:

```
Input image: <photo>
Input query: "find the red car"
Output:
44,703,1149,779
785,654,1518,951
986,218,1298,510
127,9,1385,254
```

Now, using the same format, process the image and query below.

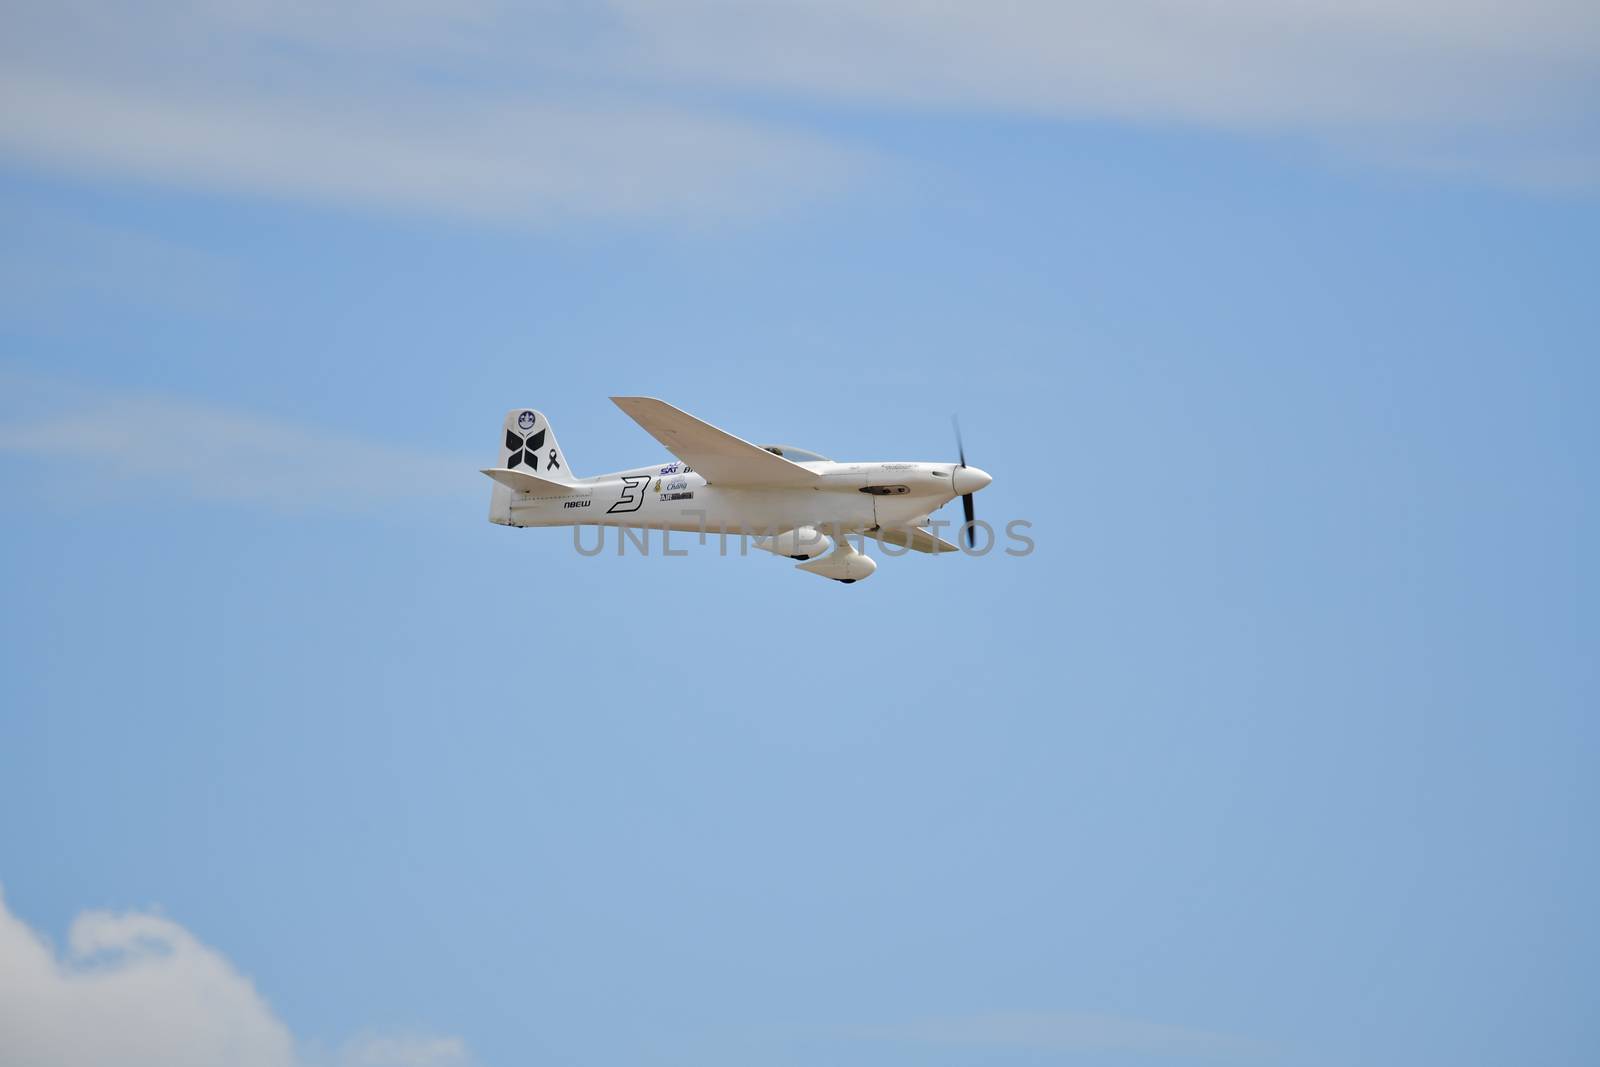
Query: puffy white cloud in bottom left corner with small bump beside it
0,897,470,1067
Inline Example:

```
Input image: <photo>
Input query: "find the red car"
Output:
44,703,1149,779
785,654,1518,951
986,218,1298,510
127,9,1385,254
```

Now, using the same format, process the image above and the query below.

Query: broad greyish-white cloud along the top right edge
616,0,1600,128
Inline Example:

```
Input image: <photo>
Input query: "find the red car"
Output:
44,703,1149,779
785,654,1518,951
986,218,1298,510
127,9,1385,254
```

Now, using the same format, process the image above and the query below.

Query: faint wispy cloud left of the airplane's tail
0,379,470,512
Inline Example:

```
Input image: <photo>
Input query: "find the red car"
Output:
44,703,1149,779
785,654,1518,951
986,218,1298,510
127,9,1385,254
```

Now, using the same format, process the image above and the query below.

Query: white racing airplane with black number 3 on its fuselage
483,397,990,584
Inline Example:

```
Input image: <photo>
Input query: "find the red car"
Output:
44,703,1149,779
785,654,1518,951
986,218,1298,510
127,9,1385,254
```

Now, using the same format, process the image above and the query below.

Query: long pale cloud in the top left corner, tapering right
0,0,861,224
